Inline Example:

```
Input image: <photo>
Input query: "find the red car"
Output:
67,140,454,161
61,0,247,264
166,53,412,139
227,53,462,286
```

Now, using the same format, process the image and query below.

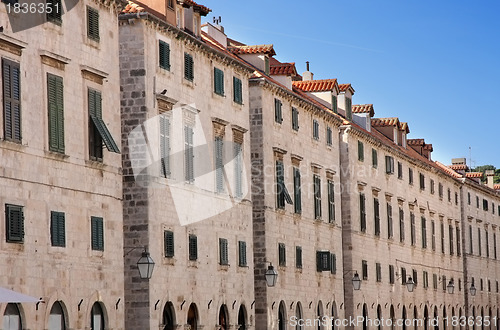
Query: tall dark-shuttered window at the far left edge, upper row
2,58,21,143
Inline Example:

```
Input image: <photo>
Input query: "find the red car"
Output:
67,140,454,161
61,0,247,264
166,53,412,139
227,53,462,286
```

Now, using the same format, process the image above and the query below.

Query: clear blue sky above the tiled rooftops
200,0,500,167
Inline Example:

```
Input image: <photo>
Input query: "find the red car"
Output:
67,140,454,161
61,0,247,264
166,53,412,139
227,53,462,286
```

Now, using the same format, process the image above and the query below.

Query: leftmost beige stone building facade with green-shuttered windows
0,0,124,329
